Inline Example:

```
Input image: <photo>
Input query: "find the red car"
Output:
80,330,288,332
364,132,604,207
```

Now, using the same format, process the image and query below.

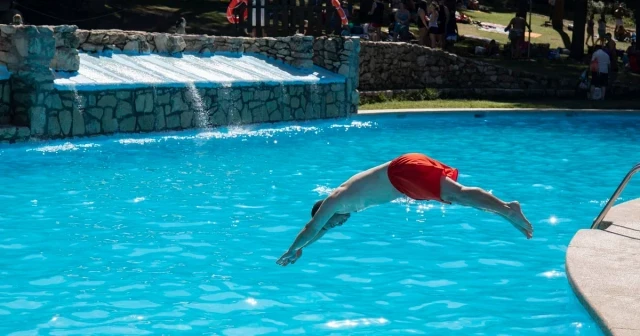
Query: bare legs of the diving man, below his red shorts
440,177,533,239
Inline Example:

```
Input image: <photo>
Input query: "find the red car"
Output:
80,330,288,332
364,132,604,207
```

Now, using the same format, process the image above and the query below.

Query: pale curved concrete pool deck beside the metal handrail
566,199,640,336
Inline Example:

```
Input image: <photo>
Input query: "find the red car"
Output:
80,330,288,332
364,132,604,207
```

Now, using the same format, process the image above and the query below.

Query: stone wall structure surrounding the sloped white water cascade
0,25,360,142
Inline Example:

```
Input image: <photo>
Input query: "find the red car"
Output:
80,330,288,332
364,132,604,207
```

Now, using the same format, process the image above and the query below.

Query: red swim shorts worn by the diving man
387,153,458,203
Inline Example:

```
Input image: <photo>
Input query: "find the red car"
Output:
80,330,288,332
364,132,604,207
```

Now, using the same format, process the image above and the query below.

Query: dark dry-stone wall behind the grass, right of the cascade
359,42,576,92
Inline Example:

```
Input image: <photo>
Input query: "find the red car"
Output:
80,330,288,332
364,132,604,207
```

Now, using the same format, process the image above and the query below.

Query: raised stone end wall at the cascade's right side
313,36,361,113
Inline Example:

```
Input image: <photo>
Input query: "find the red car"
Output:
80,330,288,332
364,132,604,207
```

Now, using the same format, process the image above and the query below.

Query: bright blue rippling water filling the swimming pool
0,114,640,335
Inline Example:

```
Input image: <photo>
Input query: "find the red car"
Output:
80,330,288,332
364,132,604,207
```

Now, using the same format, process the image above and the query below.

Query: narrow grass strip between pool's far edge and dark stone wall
358,99,640,111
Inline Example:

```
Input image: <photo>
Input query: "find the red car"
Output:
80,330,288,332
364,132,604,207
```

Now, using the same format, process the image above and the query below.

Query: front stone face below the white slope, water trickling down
37,84,349,139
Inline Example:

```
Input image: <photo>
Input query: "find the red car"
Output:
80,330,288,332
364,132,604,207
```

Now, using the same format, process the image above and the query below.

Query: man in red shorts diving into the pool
277,153,533,266
